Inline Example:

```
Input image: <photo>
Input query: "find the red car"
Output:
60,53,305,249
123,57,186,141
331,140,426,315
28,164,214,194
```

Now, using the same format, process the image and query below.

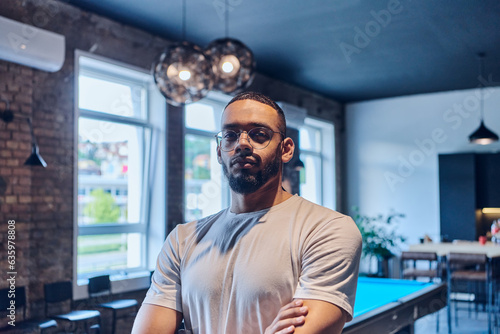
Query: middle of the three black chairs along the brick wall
44,281,101,333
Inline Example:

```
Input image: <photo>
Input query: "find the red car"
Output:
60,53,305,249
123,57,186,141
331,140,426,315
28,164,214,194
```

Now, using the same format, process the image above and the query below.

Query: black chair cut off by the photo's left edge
0,286,57,333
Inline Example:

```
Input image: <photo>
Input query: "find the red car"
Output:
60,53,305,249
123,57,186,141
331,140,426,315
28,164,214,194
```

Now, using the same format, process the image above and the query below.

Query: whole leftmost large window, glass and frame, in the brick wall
76,53,165,279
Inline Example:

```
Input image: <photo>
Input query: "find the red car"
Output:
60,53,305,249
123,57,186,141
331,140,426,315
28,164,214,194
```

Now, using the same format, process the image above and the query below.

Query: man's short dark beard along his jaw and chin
222,146,281,195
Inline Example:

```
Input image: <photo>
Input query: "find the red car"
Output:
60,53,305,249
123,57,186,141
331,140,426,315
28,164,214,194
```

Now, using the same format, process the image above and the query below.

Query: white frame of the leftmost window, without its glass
73,50,166,299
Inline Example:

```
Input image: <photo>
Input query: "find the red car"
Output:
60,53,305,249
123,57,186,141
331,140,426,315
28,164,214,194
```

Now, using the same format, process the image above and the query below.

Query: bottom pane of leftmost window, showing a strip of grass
78,233,142,275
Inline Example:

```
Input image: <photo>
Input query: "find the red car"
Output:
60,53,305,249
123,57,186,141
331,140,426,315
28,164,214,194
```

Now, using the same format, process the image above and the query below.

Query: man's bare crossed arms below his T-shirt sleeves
132,299,346,334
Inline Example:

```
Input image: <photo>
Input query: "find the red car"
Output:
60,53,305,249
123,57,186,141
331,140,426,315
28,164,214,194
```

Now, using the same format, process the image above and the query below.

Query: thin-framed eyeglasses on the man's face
215,128,284,152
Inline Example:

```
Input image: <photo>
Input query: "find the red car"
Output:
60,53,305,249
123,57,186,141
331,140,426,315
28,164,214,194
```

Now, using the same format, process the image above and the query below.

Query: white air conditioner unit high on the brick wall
0,16,66,72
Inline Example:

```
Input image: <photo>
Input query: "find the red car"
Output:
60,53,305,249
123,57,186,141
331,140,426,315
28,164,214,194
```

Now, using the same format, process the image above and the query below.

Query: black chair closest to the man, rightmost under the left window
88,275,139,334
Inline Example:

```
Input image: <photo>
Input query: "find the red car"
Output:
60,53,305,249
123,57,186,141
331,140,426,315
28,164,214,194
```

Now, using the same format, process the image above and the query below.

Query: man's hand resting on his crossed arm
265,299,308,334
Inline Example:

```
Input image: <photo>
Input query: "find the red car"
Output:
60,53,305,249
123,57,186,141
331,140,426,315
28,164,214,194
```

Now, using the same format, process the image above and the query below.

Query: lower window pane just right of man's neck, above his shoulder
300,154,323,205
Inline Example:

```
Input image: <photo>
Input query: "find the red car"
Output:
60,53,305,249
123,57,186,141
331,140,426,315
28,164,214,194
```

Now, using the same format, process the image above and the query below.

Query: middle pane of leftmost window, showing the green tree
78,117,144,225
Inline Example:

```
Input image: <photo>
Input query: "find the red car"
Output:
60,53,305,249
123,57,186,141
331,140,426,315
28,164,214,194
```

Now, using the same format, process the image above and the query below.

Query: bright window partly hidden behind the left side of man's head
184,94,229,221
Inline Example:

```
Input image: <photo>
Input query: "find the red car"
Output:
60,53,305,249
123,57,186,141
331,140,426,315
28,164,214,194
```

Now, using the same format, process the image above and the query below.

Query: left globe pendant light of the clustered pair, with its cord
153,0,214,106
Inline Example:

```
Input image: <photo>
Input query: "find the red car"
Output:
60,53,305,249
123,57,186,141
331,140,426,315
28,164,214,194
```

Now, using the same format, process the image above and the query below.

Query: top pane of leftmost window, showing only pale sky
78,74,146,118
